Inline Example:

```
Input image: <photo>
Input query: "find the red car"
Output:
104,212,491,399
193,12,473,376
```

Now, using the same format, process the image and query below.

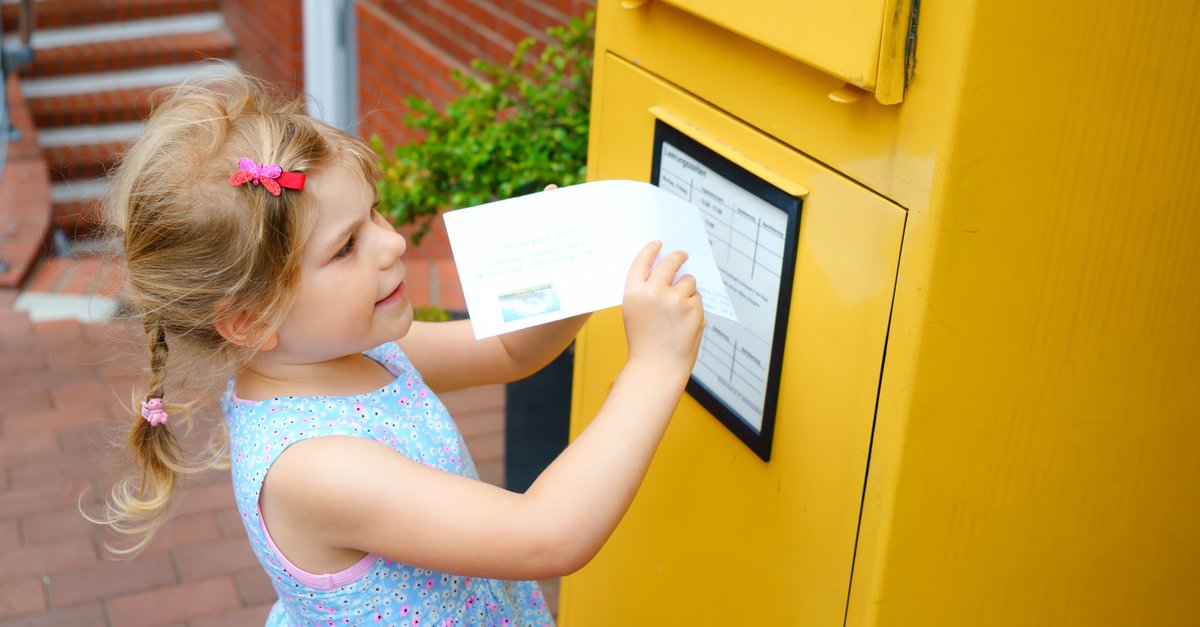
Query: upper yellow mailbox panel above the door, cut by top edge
636,0,888,89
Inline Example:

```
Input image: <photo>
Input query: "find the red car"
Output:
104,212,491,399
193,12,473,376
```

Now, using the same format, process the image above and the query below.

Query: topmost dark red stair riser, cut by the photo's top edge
2,0,221,31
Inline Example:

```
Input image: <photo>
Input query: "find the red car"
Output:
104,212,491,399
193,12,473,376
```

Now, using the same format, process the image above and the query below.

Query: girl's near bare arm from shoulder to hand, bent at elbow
262,239,703,579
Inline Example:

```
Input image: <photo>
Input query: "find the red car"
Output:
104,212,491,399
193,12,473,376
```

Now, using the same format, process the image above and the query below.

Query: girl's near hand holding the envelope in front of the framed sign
623,241,704,378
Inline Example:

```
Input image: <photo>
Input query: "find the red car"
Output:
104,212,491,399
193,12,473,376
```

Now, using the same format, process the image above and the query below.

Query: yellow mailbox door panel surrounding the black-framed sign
559,55,905,627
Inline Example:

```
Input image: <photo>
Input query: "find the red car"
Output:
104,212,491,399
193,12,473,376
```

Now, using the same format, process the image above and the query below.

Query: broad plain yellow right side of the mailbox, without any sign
847,0,1200,627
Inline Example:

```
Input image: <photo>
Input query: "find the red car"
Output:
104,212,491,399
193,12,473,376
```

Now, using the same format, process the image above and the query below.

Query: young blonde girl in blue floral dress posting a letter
106,69,703,626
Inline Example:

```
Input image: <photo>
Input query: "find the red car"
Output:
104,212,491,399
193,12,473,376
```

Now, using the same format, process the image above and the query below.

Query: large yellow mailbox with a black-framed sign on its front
559,0,1200,627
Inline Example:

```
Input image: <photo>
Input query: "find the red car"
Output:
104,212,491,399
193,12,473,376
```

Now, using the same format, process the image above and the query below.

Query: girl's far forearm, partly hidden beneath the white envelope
396,314,590,393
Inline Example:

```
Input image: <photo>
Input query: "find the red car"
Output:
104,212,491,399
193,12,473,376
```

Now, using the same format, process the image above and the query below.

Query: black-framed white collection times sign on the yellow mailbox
650,120,802,461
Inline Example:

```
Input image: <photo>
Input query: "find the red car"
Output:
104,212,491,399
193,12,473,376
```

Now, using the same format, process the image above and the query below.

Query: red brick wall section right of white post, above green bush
356,0,595,145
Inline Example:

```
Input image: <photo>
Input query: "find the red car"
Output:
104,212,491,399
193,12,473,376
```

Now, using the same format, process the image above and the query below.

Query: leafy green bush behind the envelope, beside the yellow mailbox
372,13,594,244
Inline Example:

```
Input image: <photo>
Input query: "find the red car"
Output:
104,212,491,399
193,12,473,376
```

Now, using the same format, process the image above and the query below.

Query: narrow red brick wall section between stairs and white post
221,0,304,89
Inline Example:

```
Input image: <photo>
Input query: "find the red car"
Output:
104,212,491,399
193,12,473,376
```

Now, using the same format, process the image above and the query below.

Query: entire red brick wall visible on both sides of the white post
222,0,595,145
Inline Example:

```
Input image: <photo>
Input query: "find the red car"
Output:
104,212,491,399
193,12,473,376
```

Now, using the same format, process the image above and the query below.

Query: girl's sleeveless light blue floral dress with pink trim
221,342,553,627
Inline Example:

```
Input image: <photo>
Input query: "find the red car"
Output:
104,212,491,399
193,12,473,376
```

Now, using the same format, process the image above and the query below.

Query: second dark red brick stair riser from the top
22,30,234,78
